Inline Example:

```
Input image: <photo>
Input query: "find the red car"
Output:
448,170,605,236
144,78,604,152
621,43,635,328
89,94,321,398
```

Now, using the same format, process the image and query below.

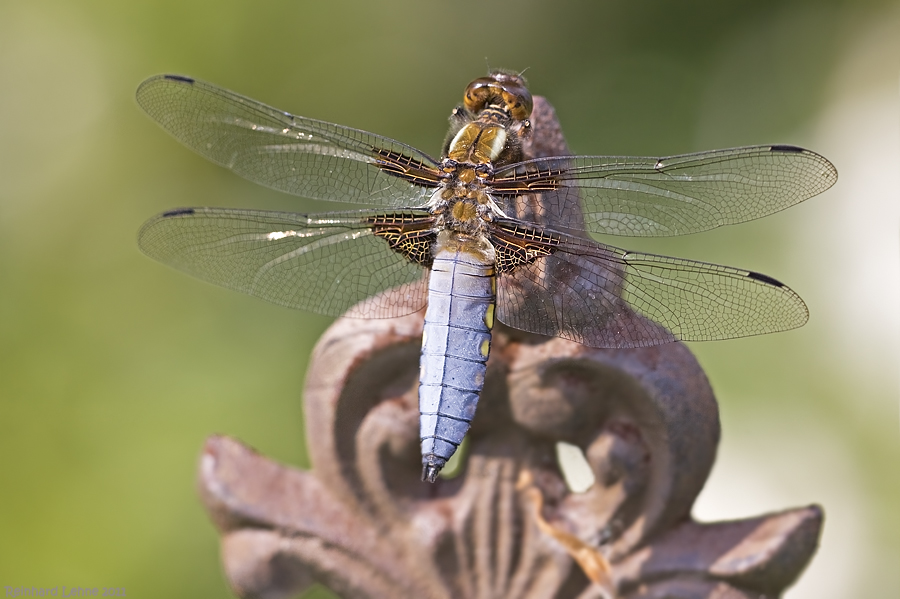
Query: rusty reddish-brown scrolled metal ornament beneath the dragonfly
199,97,823,599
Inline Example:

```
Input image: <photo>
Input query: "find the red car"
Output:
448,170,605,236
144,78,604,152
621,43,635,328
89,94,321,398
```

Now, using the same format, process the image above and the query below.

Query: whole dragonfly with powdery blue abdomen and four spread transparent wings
137,71,837,482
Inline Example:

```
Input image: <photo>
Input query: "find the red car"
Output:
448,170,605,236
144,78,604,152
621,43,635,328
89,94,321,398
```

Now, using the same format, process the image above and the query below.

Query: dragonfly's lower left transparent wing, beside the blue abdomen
138,208,427,318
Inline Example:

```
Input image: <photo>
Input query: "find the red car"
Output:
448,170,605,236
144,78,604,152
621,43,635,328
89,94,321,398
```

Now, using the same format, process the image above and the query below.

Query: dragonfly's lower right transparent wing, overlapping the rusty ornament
497,233,808,348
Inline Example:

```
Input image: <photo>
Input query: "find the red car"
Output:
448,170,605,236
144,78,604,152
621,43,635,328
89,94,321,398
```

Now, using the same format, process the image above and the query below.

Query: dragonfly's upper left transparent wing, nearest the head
137,75,437,207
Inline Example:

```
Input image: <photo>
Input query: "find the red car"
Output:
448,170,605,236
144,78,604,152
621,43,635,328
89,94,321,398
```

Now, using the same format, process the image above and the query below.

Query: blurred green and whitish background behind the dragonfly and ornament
0,0,900,599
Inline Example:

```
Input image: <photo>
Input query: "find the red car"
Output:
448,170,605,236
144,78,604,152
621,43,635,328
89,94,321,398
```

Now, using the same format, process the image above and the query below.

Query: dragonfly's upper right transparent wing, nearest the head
492,145,837,236
